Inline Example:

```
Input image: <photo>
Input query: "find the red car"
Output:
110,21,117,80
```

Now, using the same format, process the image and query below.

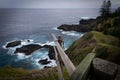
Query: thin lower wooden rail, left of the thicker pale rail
53,46,64,80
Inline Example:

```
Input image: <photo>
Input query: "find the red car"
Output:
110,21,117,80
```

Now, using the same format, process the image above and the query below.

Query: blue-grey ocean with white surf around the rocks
0,8,99,69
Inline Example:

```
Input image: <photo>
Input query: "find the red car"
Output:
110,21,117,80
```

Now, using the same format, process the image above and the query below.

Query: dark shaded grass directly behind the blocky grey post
96,44,120,65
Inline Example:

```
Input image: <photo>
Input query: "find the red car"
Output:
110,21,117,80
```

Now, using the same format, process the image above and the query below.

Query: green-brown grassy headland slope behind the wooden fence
66,31,120,65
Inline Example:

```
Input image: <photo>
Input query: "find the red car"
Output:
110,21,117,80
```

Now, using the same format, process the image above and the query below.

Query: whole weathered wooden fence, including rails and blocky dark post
52,34,118,80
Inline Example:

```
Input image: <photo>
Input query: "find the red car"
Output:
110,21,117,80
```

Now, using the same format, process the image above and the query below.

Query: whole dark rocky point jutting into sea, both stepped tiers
57,19,96,32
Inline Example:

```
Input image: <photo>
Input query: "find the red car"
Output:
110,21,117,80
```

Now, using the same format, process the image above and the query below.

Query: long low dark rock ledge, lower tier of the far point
58,24,90,32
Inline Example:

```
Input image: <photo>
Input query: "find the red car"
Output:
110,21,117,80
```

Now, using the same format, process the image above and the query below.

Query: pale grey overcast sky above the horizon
0,0,120,8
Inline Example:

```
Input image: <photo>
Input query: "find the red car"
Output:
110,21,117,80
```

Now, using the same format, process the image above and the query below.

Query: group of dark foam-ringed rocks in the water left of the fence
5,40,55,65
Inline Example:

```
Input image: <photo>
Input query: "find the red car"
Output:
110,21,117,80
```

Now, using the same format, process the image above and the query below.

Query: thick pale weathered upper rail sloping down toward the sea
52,34,75,76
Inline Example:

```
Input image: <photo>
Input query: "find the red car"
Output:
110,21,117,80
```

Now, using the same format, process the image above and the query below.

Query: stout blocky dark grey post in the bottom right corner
91,58,118,80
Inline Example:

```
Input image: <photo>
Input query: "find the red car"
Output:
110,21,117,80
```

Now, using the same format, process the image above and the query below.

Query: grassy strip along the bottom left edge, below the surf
0,66,69,80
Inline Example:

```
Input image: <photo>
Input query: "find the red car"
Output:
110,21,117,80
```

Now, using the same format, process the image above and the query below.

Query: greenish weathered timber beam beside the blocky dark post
70,53,95,80
